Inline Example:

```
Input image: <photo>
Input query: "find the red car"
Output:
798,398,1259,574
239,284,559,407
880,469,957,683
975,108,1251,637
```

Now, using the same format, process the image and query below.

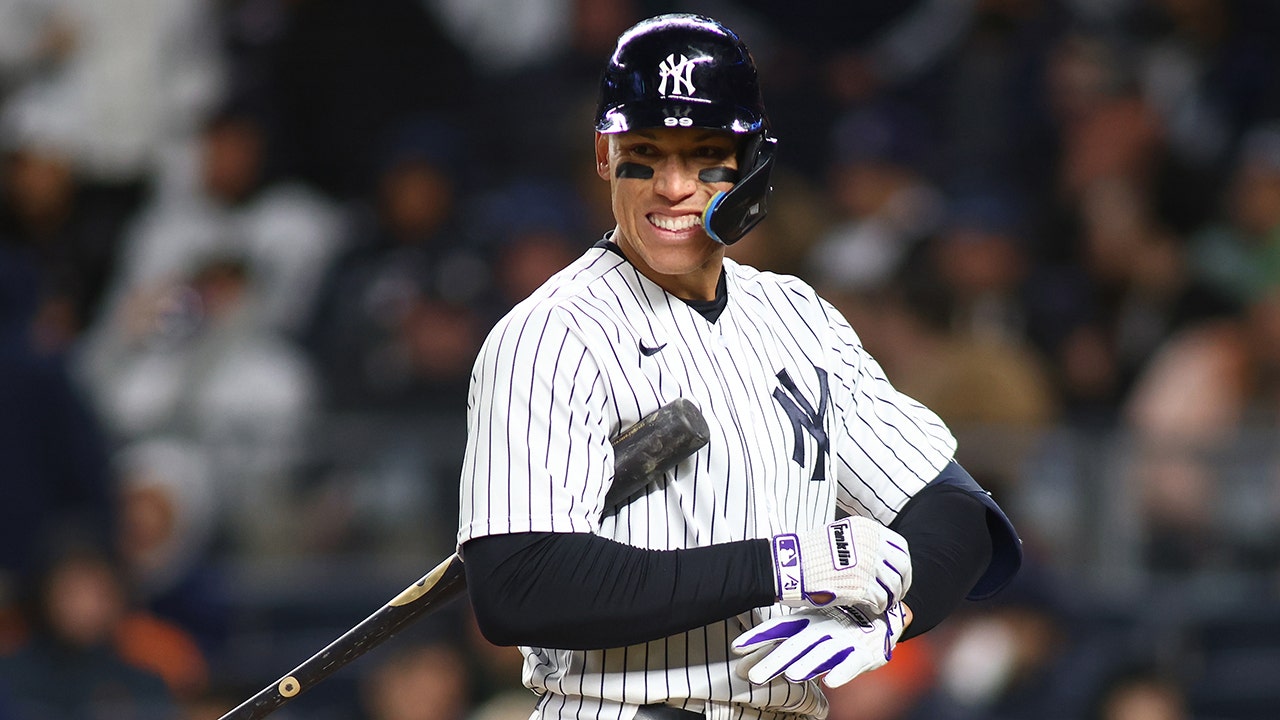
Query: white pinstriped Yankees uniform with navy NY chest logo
458,239,955,720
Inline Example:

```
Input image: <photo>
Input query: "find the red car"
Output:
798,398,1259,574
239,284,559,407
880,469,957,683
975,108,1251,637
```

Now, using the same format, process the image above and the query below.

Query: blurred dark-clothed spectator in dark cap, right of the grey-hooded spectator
306,118,490,414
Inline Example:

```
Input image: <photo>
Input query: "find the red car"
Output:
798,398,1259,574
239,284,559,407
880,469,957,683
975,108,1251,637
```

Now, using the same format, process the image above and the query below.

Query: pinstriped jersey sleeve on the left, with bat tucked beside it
458,299,613,546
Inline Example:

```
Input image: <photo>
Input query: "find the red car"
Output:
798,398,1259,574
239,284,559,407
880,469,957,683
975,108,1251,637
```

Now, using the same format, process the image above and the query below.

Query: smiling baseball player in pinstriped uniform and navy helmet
458,14,1021,720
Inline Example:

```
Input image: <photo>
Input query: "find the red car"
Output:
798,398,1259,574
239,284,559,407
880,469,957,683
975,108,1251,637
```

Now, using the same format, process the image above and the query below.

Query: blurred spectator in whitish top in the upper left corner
0,0,224,260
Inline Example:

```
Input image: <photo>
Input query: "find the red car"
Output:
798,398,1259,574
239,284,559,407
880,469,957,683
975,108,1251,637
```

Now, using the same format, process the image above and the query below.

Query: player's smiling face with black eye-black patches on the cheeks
595,128,737,300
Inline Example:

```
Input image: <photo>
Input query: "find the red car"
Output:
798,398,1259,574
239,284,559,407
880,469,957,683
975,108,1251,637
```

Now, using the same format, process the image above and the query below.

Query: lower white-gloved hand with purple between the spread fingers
733,602,905,688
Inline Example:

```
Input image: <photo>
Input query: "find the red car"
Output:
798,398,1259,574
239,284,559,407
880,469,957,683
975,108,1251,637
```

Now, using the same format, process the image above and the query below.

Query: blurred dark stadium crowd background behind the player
0,0,1280,720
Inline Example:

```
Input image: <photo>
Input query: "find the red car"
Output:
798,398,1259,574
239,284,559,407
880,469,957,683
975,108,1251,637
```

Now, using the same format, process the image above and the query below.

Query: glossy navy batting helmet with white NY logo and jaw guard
595,13,776,245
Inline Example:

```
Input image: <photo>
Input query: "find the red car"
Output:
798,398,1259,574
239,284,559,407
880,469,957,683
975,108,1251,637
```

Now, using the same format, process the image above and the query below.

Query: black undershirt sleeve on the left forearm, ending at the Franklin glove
462,533,774,650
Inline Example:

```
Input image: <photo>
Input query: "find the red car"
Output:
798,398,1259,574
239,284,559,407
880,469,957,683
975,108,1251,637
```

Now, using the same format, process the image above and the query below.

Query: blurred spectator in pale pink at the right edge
1121,224,1280,577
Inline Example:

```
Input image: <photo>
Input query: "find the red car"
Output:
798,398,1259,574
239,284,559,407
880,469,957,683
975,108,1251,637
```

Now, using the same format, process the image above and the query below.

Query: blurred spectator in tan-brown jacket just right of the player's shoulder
878,186,1061,492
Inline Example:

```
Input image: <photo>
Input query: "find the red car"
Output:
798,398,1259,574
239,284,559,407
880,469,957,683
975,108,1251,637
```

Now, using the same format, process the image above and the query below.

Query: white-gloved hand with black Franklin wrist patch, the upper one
772,515,911,616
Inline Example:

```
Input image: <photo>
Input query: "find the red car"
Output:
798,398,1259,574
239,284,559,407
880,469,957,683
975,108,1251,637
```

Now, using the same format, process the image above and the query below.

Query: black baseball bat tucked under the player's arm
220,398,710,720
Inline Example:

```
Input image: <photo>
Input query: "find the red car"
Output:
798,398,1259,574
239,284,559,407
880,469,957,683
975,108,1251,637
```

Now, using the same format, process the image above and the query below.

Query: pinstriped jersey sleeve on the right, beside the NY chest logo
822,294,956,524
